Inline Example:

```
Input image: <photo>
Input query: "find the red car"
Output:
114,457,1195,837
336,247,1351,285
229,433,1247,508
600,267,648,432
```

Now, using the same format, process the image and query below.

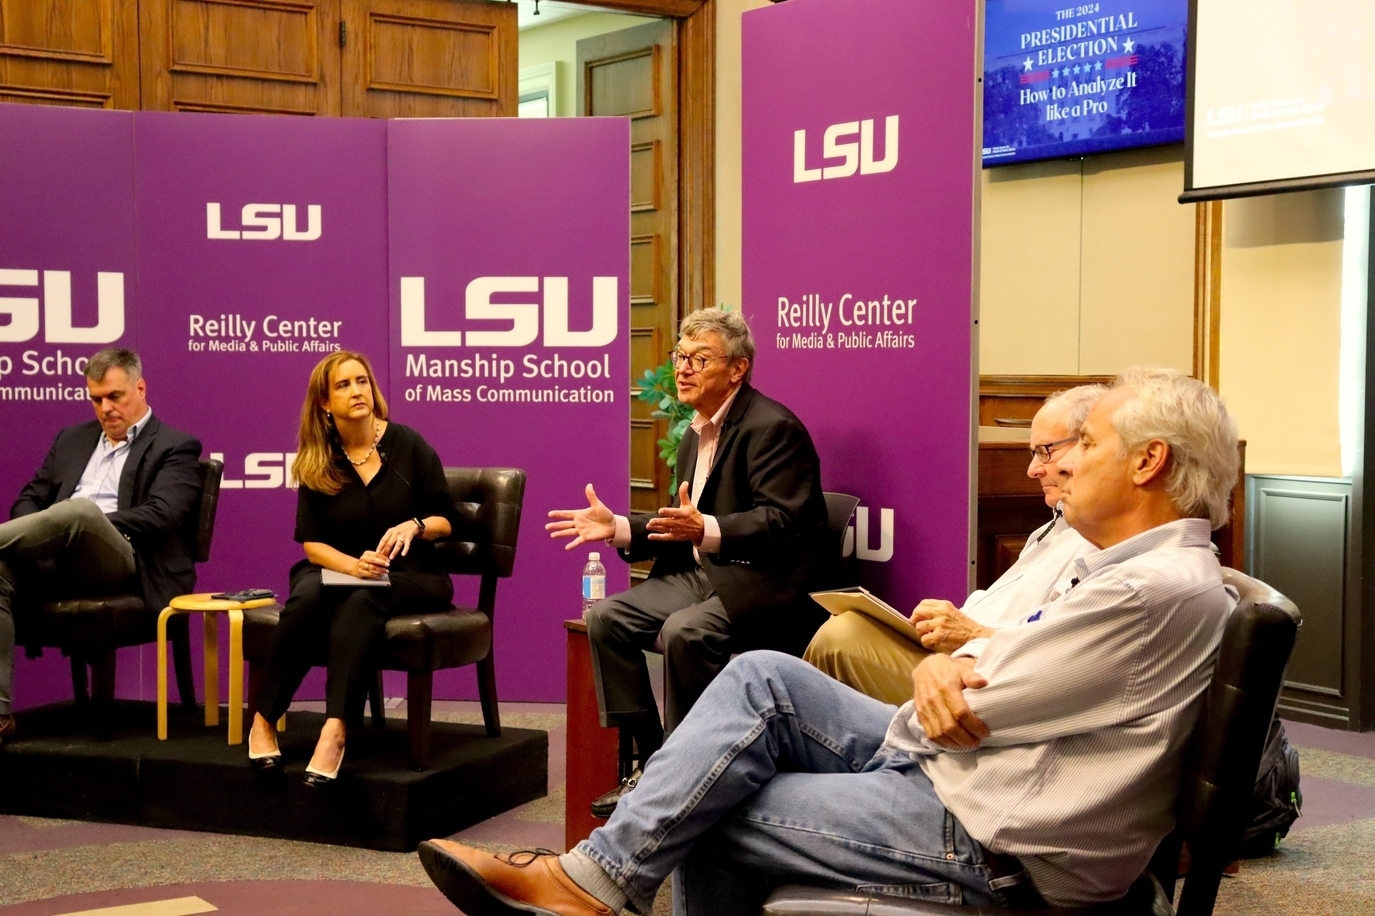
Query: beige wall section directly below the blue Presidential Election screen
979,147,1194,375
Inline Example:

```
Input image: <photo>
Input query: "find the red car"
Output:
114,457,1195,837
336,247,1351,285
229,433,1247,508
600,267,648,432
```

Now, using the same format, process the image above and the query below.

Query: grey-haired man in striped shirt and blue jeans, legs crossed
421,370,1238,916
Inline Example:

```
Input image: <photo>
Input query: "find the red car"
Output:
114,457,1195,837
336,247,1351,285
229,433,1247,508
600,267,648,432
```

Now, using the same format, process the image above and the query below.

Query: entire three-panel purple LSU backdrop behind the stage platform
0,106,630,706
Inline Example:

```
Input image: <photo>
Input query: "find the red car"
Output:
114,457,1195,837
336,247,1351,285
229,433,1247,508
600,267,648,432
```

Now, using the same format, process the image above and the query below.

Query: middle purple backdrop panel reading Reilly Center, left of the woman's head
129,111,393,699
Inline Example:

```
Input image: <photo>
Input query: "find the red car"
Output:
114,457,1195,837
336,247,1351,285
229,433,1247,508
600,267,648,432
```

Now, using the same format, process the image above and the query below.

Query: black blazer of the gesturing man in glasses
622,384,826,652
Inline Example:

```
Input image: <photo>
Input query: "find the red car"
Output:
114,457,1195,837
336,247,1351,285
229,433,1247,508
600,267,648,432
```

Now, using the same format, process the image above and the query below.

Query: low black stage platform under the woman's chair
0,701,549,851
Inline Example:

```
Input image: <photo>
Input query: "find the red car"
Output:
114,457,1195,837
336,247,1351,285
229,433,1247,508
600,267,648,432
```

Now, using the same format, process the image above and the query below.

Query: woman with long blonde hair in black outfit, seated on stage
249,351,454,785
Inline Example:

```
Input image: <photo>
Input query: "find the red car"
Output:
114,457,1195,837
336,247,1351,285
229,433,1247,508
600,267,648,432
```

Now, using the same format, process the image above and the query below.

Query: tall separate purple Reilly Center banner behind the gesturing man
743,0,979,608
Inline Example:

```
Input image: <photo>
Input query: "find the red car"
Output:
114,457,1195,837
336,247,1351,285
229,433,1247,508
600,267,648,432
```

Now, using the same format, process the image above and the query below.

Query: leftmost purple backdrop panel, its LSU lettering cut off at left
0,105,139,707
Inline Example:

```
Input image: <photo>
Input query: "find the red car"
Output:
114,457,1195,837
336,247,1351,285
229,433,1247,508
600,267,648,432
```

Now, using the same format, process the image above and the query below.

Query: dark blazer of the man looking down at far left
10,417,201,611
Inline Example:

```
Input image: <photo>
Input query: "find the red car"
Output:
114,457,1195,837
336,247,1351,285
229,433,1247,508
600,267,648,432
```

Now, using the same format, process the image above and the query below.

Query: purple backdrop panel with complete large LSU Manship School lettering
386,118,630,700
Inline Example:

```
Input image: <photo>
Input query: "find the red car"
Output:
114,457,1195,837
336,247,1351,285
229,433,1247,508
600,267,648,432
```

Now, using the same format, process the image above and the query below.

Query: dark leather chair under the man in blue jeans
763,569,1299,916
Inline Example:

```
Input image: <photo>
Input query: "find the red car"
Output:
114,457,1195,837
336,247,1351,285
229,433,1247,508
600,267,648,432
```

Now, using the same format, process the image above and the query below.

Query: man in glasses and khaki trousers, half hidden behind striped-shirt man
802,385,1108,706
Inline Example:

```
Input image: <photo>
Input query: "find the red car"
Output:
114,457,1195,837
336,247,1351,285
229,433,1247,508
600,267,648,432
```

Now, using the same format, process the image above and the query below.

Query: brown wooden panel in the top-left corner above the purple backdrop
0,0,139,109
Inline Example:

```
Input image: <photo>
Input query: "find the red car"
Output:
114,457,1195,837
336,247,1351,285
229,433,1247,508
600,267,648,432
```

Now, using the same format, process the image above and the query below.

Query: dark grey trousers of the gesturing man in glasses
587,569,736,732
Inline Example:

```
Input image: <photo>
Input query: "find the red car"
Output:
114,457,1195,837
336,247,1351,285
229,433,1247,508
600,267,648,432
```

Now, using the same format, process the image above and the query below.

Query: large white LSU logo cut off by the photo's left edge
0,268,124,344
